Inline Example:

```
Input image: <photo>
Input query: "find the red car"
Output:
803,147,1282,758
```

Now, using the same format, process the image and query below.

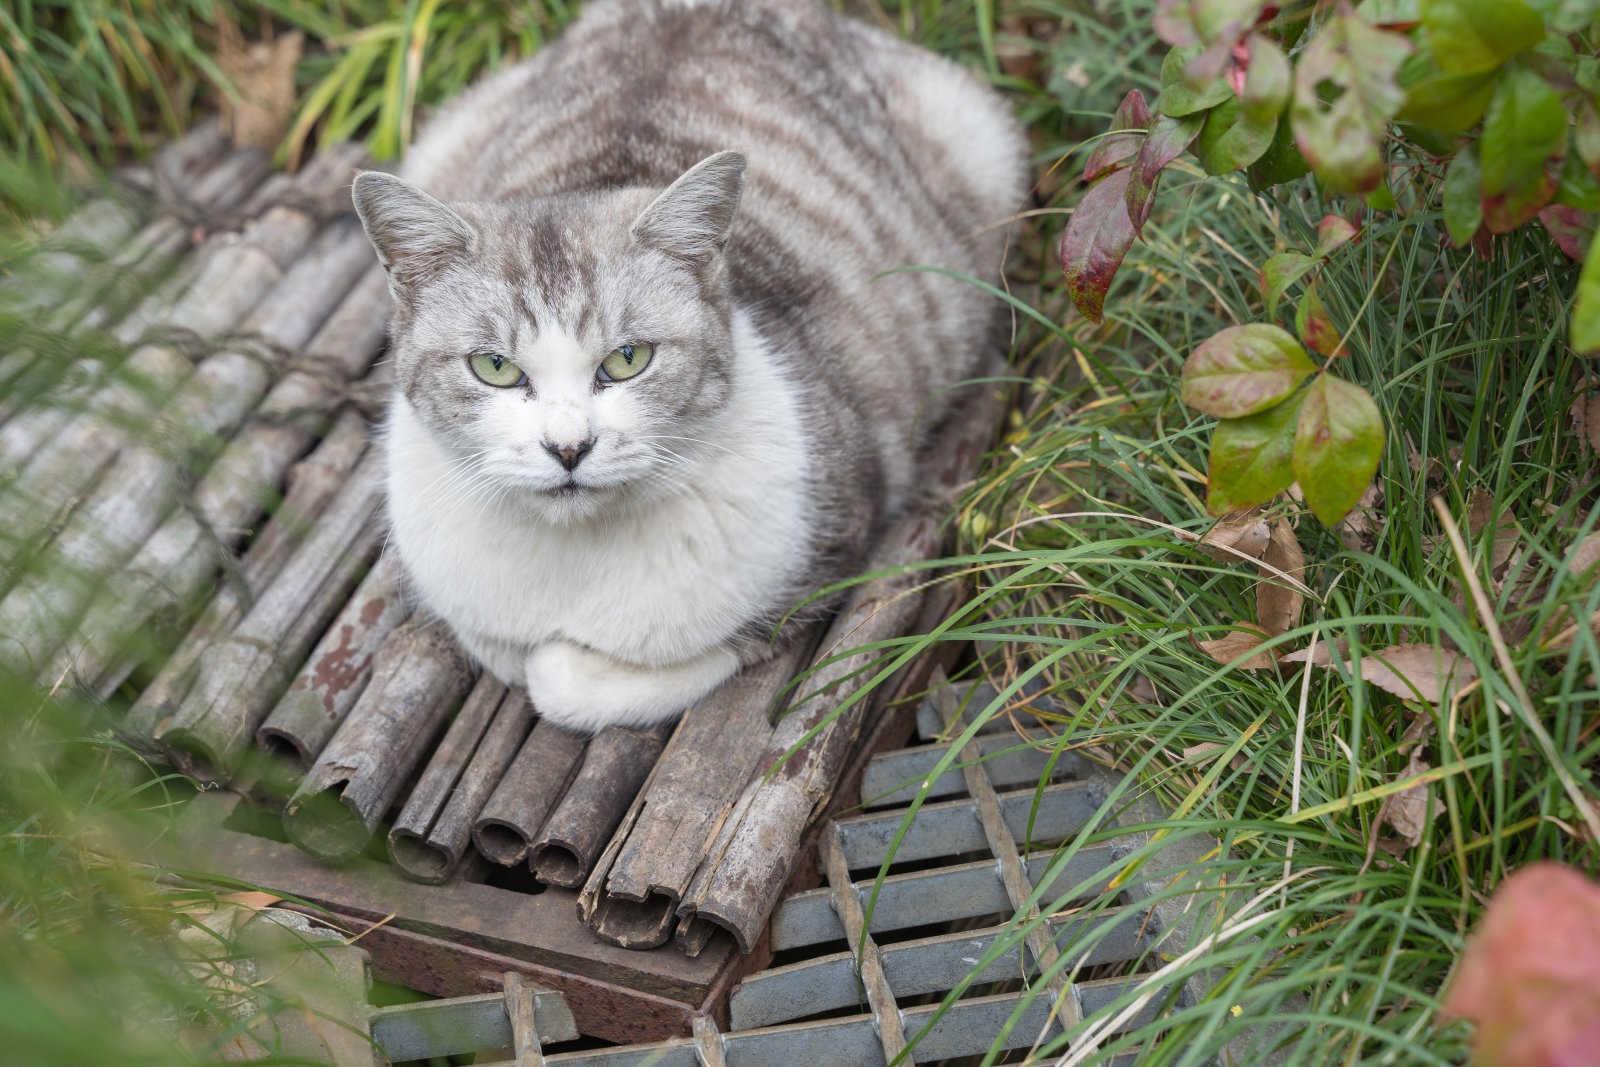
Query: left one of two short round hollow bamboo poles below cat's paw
472,718,584,867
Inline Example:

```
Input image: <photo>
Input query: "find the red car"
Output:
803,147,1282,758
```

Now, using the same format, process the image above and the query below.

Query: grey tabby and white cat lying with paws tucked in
355,0,1026,729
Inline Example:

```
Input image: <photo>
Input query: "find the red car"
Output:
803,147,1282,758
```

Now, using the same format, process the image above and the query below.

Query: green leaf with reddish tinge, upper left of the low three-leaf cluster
1182,323,1317,419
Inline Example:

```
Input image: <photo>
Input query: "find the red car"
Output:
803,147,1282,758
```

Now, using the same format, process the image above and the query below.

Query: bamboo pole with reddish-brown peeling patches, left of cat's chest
256,555,411,768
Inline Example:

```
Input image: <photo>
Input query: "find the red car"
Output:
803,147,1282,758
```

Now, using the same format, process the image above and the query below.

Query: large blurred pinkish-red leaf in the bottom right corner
1442,861,1600,1067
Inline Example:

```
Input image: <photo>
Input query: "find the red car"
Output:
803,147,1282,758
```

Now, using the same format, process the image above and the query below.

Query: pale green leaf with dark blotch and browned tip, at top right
1291,14,1411,192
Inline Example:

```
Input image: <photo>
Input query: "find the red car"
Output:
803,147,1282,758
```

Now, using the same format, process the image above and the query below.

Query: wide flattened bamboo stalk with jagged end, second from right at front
578,640,814,949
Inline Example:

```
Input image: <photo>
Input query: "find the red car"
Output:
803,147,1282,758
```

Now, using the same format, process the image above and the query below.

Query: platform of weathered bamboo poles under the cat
0,133,998,953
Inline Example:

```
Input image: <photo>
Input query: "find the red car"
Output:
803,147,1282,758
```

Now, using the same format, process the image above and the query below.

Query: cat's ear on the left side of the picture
350,171,477,298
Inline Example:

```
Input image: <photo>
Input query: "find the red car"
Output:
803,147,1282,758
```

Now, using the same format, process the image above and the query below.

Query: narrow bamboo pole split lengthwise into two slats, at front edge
389,684,533,885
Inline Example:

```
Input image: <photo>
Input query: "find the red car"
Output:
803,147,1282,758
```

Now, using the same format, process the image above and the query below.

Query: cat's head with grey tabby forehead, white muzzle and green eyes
354,152,744,522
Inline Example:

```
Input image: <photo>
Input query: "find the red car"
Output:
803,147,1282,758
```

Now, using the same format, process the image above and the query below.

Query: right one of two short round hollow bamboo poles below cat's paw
528,723,672,889
